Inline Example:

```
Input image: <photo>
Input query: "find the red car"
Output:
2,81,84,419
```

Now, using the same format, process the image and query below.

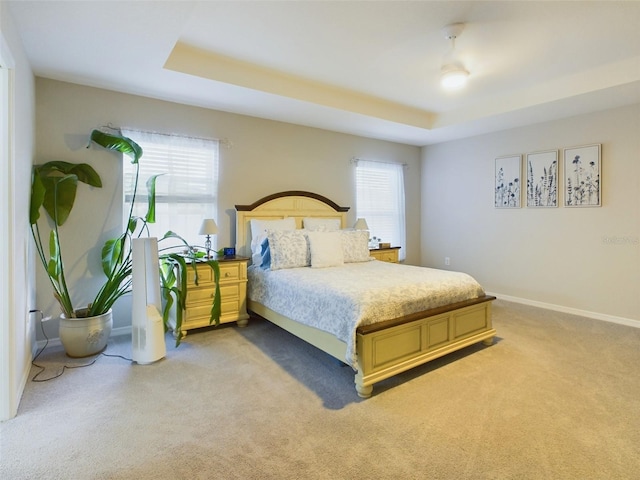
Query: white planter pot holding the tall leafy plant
58,310,113,358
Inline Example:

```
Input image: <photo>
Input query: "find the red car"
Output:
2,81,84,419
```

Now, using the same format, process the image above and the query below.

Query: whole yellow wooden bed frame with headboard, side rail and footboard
236,191,496,398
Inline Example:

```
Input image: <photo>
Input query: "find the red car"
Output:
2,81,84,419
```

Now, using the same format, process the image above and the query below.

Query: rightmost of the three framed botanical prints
564,144,602,207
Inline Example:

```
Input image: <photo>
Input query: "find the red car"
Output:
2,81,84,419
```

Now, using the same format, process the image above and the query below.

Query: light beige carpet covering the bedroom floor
0,300,640,480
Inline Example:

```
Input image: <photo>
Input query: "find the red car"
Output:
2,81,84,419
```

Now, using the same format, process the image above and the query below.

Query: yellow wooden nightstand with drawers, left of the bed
172,256,249,336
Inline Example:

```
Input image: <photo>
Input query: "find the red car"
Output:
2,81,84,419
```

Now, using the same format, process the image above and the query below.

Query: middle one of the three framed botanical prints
526,150,558,207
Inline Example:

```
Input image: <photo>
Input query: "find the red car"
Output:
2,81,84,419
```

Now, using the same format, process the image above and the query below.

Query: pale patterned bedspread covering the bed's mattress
248,261,484,368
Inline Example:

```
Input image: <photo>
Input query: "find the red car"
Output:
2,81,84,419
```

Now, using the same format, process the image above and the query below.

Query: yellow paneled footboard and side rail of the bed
248,296,496,398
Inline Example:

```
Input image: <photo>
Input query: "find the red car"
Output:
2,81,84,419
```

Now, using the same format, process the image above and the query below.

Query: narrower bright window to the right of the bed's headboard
356,160,406,260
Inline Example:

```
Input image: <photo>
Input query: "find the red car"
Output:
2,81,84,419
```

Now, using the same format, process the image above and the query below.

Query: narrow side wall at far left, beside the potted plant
0,2,37,420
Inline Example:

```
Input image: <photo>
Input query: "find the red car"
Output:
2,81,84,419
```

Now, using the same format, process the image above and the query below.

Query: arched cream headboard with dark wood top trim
236,190,349,258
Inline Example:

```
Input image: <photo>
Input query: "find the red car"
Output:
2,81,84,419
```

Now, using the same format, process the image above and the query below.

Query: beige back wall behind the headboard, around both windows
36,78,420,337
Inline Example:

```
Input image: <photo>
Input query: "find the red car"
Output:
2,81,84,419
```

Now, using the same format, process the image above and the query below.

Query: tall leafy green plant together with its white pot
29,130,220,357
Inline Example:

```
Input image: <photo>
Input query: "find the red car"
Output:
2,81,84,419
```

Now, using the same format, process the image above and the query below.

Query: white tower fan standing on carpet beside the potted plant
131,237,167,365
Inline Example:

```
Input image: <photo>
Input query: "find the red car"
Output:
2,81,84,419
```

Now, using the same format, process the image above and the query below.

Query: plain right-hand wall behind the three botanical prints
422,105,640,320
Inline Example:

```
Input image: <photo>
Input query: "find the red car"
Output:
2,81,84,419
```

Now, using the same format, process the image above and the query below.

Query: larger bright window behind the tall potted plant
122,129,219,248
